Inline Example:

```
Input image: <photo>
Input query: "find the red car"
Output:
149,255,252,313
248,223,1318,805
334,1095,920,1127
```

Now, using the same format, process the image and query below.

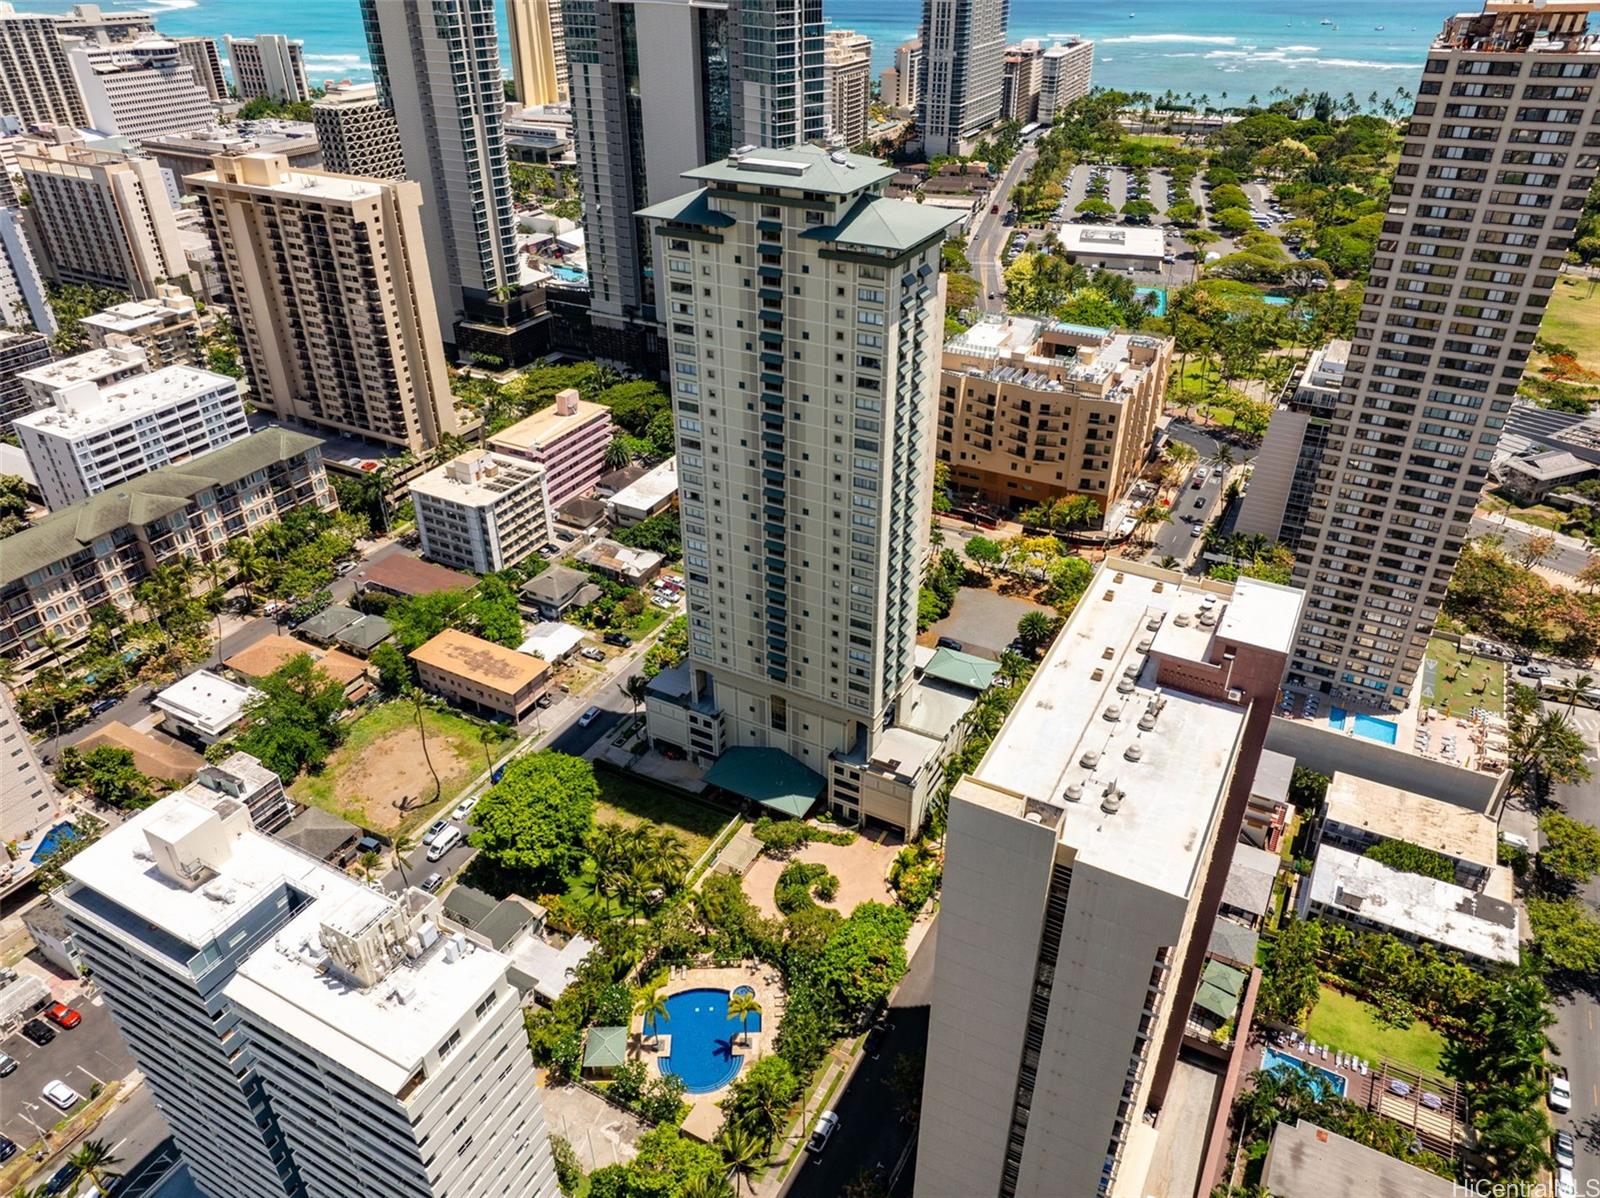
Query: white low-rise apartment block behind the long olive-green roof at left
13,358,250,510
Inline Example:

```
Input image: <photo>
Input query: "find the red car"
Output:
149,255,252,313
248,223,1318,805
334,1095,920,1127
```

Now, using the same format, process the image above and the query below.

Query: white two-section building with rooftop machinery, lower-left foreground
56,787,557,1198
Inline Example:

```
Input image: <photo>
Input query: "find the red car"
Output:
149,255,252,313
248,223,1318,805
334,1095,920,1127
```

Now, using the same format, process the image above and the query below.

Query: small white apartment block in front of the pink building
411,449,555,574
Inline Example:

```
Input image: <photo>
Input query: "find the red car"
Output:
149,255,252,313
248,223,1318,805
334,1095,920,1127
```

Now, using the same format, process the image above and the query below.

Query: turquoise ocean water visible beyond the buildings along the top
31,0,1462,104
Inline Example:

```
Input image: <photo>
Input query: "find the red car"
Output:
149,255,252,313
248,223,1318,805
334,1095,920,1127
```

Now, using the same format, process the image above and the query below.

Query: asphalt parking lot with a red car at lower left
0,996,134,1148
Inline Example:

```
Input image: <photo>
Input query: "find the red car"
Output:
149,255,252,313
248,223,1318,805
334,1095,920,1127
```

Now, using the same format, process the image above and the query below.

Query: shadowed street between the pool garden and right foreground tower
786,916,939,1198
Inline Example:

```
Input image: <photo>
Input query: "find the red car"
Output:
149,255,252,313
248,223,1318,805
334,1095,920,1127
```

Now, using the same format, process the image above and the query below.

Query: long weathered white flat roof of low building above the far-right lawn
1310,845,1520,964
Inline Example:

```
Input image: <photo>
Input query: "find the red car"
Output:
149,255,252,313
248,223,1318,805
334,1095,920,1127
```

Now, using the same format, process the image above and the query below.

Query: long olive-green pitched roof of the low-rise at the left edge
0,427,322,585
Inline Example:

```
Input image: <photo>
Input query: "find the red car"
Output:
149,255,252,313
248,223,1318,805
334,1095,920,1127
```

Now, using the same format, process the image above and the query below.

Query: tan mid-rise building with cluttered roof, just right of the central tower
939,317,1173,510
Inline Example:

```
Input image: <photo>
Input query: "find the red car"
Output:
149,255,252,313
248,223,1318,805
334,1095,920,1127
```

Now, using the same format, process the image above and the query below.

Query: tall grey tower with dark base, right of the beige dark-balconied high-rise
362,0,542,365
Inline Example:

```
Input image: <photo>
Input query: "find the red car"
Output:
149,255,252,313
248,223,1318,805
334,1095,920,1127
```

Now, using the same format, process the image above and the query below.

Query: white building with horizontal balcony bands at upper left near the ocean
67,37,216,139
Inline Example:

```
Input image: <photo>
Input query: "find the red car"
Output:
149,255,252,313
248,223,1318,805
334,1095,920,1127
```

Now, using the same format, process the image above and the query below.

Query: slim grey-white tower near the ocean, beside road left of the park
922,0,1010,155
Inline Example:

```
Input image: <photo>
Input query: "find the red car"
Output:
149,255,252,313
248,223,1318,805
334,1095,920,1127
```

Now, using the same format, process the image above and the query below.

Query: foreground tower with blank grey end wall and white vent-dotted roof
915,558,1301,1198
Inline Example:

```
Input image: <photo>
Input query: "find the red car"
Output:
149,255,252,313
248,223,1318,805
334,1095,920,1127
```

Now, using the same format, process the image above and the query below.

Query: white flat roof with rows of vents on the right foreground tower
973,558,1246,896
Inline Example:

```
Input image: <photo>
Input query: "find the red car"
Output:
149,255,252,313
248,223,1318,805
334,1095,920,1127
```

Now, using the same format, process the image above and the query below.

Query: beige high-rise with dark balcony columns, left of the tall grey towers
190,154,459,453
